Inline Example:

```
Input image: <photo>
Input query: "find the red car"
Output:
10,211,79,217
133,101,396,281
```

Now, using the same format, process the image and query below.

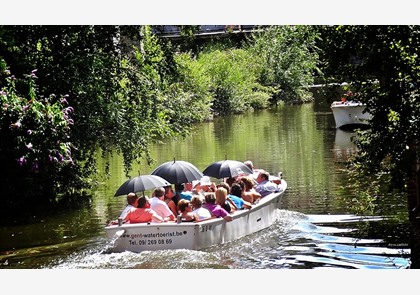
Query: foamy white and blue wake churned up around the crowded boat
45,209,410,269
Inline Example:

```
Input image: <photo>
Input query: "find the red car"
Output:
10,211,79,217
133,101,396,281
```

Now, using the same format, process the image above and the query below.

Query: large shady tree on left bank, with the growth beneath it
0,26,212,224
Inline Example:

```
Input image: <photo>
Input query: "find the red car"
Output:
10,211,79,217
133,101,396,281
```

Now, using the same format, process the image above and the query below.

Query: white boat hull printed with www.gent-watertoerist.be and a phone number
105,180,287,252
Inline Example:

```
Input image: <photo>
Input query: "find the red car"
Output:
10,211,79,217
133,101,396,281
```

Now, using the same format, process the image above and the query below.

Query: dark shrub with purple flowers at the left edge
0,70,74,204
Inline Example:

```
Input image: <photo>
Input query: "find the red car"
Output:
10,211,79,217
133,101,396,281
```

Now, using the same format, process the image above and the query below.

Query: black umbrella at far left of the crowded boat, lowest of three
114,175,171,197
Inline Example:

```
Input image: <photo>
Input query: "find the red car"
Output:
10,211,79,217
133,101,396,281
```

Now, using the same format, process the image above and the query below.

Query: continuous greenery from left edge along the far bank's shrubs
0,25,324,220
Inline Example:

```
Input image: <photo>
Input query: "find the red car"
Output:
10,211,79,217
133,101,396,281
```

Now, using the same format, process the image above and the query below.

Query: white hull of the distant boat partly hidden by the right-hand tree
331,101,372,128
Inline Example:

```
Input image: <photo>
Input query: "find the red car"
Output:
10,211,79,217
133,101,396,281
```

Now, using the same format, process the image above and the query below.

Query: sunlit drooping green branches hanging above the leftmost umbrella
104,26,209,172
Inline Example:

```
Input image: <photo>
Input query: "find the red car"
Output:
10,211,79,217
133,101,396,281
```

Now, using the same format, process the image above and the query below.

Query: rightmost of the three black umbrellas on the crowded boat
203,160,253,179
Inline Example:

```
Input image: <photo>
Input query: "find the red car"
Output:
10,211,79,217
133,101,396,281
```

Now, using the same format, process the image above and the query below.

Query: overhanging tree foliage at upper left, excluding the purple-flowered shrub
0,26,208,208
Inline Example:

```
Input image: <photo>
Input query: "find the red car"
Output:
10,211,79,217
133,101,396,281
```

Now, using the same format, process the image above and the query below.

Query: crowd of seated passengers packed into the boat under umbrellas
111,161,281,224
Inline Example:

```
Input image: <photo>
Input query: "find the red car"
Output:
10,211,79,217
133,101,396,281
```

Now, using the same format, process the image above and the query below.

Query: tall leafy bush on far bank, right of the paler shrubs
250,26,319,102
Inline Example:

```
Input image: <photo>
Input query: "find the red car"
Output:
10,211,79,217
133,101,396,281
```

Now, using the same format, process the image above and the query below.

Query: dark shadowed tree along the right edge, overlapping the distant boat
320,26,420,268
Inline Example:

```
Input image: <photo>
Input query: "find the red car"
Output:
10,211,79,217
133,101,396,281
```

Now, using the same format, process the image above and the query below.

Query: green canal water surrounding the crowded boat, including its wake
0,104,410,269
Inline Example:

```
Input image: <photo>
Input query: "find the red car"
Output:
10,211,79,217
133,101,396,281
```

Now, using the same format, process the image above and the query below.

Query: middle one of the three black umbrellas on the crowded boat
152,159,203,183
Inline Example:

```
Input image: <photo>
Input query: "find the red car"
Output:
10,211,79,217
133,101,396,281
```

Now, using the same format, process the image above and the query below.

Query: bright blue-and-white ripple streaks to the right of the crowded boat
270,210,410,269
